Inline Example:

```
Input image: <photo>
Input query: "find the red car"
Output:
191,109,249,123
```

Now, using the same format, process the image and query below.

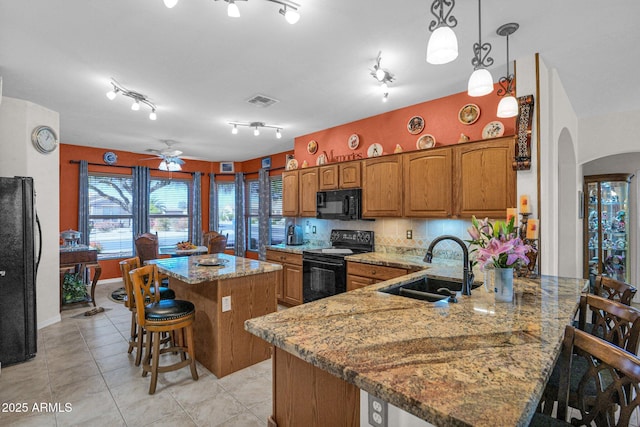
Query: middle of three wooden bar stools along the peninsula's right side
538,294,640,415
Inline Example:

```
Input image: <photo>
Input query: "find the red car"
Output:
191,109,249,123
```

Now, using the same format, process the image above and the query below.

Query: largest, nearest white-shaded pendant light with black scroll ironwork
427,0,458,65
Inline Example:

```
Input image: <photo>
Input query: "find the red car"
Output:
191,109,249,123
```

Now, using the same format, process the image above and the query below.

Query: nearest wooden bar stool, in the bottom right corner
529,326,640,427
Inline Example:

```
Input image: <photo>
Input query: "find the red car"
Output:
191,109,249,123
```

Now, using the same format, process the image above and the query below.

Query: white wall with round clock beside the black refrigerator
0,97,60,328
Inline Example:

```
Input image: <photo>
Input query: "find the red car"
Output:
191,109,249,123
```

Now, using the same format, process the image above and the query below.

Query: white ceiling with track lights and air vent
0,0,640,161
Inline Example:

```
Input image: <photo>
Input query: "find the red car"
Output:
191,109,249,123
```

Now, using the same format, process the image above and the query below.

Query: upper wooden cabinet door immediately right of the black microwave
362,154,402,218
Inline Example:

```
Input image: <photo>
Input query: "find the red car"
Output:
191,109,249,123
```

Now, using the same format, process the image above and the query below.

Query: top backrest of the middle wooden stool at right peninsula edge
578,295,640,354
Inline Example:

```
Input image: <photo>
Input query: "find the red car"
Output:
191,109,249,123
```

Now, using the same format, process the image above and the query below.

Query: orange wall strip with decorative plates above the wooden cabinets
294,85,516,168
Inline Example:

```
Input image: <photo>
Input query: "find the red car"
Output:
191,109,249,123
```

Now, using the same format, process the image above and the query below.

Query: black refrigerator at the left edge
0,177,42,366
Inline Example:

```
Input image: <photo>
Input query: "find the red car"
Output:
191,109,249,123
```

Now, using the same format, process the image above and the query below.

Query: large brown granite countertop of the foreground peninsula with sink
245,262,587,427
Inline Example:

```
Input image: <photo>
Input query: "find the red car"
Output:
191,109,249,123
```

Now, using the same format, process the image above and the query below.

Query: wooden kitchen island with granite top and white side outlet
149,254,282,378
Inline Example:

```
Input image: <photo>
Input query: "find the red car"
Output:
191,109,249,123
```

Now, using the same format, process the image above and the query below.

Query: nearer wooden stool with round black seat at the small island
129,264,198,394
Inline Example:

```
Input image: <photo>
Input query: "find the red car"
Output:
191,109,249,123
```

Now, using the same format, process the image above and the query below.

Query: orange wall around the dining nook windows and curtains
60,144,293,279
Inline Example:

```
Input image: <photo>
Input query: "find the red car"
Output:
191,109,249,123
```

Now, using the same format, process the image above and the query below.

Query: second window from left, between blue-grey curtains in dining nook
149,178,191,246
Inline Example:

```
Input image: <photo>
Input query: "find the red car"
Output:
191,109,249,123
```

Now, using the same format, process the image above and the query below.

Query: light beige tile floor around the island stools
0,282,272,427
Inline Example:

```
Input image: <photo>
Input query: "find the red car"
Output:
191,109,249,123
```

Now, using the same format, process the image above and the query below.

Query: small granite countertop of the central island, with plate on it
148,254,282,284
